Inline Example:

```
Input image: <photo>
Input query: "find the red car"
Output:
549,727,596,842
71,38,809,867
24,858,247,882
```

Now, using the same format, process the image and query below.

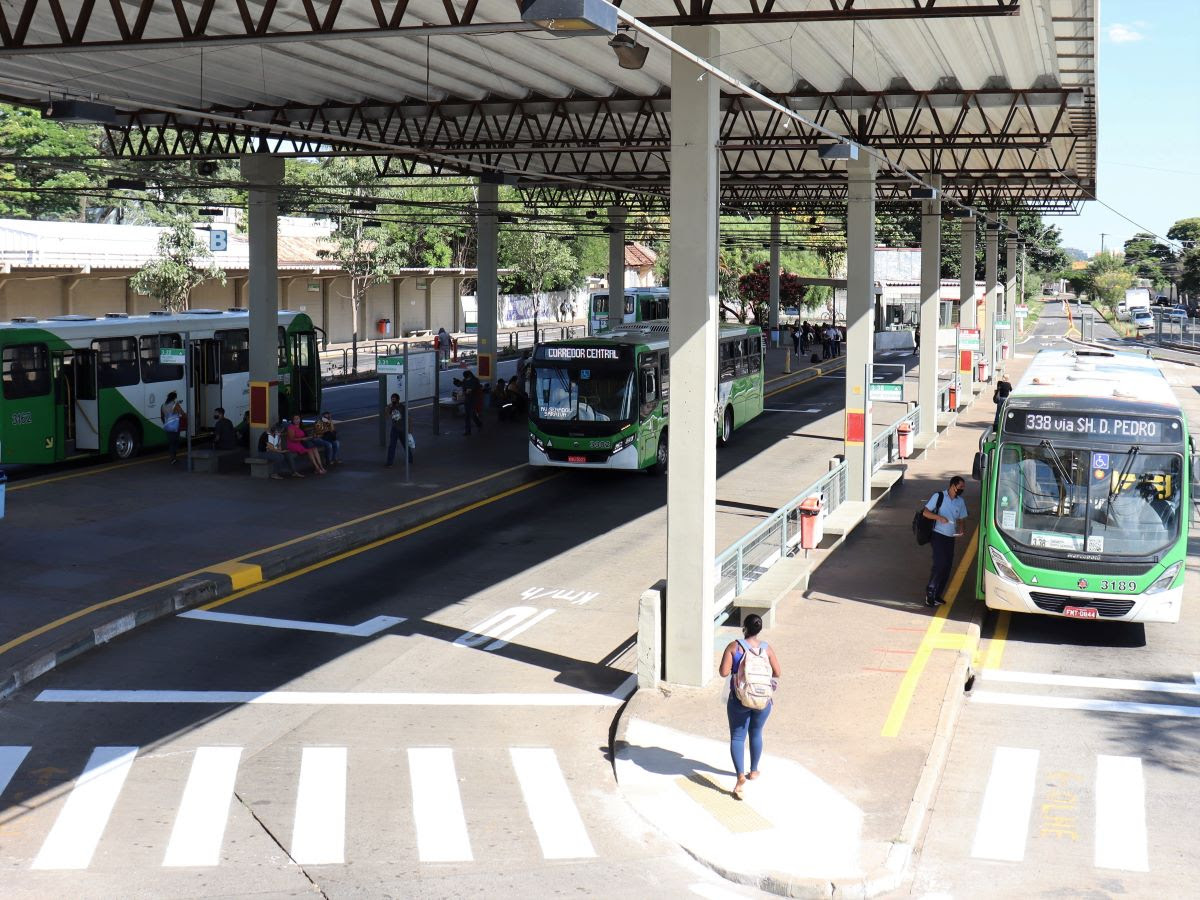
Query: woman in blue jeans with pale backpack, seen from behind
720,614,780,800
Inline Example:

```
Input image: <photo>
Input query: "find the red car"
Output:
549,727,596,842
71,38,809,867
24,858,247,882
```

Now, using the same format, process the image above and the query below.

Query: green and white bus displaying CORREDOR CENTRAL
528,320,763,474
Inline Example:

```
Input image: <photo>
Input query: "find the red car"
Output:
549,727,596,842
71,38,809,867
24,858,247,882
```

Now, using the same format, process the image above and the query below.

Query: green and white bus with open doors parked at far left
0,308,320,463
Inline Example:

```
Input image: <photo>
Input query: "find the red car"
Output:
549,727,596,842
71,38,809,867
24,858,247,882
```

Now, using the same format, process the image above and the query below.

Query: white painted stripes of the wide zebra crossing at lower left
0,746,598,869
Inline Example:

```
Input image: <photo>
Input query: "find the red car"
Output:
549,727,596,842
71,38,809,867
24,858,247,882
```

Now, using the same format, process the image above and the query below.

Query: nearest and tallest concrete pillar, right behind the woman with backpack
665,25,720,686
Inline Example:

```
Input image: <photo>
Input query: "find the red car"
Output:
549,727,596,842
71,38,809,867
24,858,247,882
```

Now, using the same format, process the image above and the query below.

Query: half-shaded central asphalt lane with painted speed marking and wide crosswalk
0,352,892,898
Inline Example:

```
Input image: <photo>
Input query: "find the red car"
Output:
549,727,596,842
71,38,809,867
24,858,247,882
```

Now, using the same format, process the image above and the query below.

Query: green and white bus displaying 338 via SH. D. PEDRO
976,349,1198,622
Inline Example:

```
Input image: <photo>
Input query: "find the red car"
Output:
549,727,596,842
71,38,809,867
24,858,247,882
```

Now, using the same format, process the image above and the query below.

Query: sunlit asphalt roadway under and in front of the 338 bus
898,306,1200,900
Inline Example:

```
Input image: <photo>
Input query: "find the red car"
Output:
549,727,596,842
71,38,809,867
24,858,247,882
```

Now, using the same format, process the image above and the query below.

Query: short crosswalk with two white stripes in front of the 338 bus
971,746,1150,871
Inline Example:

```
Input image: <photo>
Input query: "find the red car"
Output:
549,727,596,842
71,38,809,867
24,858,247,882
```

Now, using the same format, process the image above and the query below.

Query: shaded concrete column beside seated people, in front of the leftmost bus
241,154,283,448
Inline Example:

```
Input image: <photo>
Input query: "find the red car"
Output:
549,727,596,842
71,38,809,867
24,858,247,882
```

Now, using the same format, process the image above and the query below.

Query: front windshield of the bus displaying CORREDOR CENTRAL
532,365,635,421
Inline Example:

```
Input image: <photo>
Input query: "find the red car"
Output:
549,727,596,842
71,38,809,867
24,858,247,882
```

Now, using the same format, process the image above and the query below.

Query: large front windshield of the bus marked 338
995,440,1182,556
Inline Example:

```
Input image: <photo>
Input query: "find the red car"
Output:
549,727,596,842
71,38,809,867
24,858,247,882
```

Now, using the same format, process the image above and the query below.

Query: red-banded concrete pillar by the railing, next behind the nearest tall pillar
845,154,878,500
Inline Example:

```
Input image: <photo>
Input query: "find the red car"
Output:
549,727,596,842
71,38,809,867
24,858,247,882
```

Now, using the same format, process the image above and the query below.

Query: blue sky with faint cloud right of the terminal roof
1046,0,1200,256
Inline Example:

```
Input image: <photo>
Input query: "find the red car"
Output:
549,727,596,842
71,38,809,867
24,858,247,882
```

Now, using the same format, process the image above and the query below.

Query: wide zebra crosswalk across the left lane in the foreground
0,746,596,870
